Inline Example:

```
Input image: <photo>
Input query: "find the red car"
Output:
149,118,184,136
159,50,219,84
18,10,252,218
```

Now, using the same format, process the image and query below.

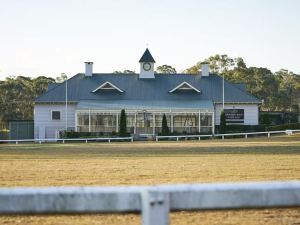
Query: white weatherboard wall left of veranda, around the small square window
34,104,75,139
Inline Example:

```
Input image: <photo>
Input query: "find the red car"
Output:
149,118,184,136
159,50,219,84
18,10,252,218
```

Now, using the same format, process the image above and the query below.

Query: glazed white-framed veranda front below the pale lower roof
75,109,214,135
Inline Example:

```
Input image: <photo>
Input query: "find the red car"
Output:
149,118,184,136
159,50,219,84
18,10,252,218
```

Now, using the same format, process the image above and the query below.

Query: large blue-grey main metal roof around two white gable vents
36,73,260,104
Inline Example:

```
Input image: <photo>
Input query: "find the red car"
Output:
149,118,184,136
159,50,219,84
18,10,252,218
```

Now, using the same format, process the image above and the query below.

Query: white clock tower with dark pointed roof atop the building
139,48,155,79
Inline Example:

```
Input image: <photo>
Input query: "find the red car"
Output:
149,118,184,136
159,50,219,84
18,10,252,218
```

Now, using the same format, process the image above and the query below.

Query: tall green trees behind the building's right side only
184,55,300,112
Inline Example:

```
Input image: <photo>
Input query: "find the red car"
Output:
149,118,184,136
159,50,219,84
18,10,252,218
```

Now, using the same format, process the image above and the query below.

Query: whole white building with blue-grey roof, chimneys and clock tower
34,49,260,138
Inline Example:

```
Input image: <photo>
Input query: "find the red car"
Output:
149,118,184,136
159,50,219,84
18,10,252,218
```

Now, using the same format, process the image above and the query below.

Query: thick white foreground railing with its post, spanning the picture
0,181,300,225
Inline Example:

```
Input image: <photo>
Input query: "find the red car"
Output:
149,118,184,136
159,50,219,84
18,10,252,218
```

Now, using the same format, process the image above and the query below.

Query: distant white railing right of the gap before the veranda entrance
156,130,300,141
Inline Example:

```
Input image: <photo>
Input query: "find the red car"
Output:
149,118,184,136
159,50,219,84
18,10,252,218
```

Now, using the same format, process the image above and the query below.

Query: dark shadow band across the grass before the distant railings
0,145,300,159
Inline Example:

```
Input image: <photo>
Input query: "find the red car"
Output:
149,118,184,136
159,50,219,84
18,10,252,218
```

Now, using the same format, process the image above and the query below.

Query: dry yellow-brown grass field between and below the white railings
0,135,300,225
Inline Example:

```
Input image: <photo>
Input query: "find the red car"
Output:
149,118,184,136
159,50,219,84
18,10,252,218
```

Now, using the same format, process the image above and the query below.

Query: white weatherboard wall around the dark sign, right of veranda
215,104,259,125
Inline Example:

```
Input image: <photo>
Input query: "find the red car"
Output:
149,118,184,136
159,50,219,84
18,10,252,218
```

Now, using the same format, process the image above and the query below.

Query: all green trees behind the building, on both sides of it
0,55,300,121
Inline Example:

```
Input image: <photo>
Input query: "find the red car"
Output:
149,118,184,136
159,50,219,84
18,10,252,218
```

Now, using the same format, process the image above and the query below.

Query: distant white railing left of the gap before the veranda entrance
0,137,133,144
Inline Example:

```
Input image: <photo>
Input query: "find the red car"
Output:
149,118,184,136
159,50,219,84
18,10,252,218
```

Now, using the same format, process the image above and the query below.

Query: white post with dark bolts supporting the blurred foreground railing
141,190,170,225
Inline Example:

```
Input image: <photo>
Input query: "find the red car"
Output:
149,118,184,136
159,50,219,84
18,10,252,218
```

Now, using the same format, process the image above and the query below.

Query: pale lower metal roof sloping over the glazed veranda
77,100,214,111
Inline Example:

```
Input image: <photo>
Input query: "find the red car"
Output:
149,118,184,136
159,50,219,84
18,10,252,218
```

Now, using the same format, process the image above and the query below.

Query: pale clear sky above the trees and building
0,0,300,79
